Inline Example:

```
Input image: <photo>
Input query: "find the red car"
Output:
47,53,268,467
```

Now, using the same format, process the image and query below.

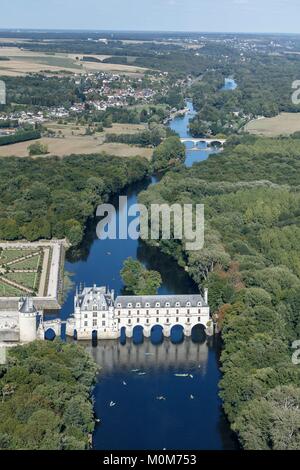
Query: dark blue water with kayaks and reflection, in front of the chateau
87,337,235,450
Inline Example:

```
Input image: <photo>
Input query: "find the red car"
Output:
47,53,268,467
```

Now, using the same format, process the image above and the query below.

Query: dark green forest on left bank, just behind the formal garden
0,154,149,246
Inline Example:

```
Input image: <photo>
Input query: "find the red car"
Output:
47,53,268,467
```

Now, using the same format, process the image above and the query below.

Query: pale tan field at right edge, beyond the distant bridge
244,113,300,137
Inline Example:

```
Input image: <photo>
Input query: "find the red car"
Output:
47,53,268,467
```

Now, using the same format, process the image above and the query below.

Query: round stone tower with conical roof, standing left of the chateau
19,297,37,343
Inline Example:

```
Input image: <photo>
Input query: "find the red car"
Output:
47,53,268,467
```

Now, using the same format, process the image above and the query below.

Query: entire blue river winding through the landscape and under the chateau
61,98,236,450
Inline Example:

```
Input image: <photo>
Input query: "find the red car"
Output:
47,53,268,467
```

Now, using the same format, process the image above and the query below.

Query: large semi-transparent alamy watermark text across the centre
96,196,204,251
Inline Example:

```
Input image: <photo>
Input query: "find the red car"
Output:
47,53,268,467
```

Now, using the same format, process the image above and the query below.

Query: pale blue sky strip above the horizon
0,0,300,33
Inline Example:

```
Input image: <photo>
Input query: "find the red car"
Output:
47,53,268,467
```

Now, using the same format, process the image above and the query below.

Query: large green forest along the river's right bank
140,138,300,449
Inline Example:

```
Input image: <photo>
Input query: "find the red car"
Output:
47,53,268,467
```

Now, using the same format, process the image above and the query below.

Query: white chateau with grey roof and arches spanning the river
66,285,211,340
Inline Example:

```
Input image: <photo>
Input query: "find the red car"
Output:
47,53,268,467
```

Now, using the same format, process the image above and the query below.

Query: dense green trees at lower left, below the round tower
0,341,97,450
